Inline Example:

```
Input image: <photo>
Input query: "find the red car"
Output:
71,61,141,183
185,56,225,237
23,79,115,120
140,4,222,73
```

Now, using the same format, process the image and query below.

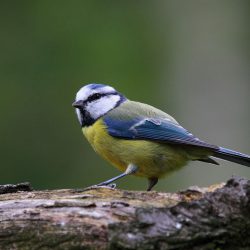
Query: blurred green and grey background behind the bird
0,0,250,191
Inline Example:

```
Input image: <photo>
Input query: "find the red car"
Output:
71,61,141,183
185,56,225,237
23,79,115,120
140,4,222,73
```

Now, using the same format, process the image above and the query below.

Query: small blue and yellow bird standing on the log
72,83,250,191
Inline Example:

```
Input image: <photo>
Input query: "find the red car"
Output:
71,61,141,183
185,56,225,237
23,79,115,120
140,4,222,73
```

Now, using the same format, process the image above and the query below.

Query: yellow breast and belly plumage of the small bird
83,119,189,178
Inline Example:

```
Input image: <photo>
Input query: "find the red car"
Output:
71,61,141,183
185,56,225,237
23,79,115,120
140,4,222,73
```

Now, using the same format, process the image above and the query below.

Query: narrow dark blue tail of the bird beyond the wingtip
213,147,250,167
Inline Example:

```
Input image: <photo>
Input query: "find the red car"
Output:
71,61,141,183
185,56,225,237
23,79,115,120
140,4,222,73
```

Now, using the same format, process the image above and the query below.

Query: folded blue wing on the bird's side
104,116,218,150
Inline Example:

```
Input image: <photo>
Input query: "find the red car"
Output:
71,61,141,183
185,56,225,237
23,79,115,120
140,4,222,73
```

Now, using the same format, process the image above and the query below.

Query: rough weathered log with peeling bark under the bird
0,177,250,250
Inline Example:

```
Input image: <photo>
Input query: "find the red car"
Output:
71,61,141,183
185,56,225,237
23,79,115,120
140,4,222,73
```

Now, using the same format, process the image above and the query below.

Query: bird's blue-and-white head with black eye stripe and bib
72,83,127,127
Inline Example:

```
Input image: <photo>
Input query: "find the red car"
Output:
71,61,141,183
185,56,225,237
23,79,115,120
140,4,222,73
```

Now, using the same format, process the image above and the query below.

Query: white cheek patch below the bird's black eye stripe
86,95,120,119
